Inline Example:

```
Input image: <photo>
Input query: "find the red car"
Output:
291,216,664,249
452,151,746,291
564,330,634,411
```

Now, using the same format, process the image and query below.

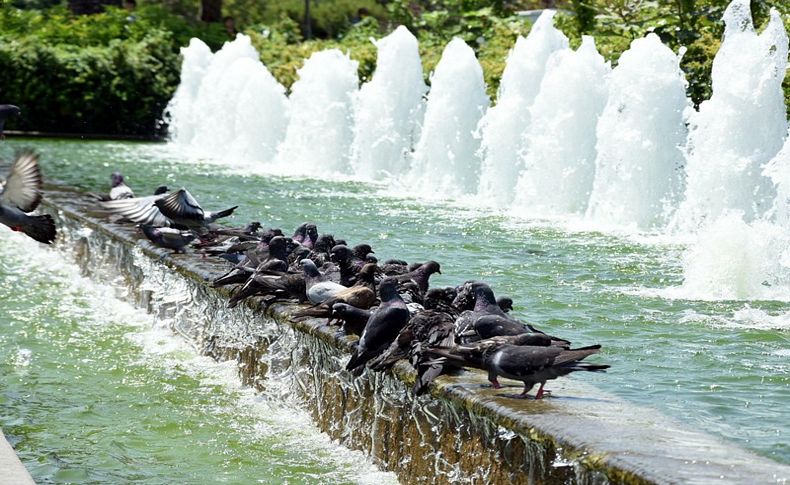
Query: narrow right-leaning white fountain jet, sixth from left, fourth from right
478,10,568,207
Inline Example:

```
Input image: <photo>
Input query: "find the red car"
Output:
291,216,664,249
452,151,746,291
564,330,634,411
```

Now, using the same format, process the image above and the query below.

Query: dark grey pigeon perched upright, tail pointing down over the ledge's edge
346,278,410,375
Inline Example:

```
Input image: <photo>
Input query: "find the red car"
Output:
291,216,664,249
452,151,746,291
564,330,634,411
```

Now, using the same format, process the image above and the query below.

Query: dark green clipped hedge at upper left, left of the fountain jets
0,7,195,135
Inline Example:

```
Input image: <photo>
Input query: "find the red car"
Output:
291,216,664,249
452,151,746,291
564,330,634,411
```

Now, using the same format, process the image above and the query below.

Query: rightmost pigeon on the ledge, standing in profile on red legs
432,334,610,399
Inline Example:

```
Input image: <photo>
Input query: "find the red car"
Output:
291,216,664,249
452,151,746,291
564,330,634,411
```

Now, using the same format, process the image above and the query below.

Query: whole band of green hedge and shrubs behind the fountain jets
0,0,790,136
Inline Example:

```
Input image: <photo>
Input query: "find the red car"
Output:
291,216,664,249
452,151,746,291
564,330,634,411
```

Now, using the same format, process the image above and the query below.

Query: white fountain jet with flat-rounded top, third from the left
276,49,359,176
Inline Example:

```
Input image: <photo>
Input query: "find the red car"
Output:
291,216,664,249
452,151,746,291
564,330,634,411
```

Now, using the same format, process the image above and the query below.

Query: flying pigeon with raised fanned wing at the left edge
0,151,56,244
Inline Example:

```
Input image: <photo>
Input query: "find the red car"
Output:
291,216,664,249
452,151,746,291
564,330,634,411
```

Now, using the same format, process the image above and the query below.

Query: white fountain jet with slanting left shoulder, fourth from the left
351,26,428,179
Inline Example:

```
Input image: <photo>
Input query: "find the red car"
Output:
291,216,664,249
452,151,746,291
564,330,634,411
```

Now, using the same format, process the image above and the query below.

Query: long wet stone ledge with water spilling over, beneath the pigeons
38,188,790,483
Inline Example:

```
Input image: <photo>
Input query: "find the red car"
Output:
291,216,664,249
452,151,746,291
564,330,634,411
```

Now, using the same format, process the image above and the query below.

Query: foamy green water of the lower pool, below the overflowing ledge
0,230,397,483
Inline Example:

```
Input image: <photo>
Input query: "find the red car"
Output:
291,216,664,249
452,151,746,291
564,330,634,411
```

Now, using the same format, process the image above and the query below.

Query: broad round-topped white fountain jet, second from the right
588,34,690,229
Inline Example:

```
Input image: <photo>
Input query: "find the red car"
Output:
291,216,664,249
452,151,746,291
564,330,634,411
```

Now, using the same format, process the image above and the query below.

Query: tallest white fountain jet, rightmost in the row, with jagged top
674,0,787,232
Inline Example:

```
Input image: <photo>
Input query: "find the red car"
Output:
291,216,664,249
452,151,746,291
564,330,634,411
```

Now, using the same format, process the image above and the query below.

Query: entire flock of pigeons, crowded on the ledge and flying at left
0,105,609,399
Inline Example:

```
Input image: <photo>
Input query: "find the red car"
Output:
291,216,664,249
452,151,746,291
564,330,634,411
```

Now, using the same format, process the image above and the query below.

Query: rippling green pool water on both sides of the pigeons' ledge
0,139,790,476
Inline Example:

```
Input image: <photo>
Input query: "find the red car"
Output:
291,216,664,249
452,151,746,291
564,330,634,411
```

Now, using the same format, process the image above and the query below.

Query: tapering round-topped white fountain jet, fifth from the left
407,38,489,197
